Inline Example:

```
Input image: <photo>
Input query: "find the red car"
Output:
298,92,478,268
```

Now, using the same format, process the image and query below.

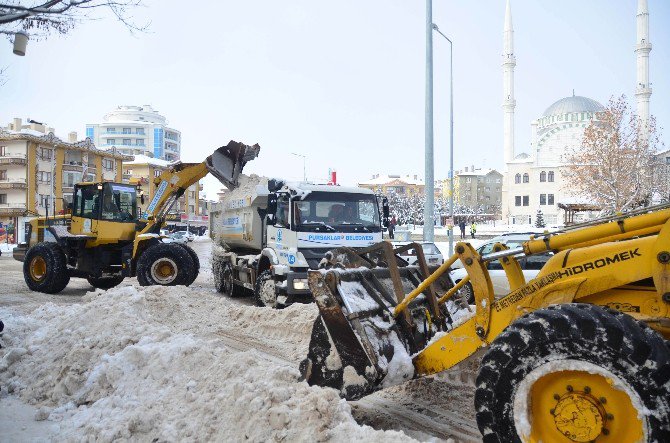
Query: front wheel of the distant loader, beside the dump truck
137,243,195,286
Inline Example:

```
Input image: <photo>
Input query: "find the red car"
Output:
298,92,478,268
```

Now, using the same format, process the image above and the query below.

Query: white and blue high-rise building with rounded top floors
86,105,181,161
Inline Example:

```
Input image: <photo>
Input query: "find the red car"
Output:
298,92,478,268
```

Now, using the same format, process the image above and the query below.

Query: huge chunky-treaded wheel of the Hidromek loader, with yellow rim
475,303,670,443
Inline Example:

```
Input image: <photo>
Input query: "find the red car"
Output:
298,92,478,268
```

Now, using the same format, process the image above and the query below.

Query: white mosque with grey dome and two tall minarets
502,0,652,226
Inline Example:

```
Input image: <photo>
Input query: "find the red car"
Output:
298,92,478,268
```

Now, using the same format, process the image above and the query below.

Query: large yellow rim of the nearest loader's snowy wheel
514,360,647,443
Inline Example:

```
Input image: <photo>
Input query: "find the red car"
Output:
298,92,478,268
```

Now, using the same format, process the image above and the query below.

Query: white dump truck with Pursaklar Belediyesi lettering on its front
210,176,388,307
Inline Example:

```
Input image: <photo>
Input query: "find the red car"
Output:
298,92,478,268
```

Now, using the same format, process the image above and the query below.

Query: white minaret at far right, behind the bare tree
635,0,651,124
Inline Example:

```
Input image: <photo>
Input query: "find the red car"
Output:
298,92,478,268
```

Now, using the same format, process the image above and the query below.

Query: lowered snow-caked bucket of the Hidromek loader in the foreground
300,242,453,400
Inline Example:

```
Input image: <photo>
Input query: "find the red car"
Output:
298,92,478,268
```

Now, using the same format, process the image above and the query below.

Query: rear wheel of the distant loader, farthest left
23,242,70,294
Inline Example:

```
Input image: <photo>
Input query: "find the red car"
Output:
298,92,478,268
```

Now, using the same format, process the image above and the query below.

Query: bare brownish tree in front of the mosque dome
562,95,661,212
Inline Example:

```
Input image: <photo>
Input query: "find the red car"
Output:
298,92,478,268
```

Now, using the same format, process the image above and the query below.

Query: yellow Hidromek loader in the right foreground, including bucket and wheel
301,205,670,443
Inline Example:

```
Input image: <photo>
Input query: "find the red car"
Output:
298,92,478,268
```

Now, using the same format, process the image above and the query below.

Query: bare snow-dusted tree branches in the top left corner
0,0,148,40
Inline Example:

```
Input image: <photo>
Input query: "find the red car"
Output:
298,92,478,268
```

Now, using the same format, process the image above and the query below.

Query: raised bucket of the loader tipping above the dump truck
205,140,261,190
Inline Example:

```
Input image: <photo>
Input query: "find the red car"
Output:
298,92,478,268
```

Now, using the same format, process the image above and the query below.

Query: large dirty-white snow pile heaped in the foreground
0,286,409,441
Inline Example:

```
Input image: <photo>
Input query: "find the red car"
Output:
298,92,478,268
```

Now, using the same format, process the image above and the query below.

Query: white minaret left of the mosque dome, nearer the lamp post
502,0,516,168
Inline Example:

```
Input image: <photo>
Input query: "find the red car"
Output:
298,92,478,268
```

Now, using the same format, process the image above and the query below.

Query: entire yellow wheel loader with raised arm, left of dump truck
14,141,260,294
